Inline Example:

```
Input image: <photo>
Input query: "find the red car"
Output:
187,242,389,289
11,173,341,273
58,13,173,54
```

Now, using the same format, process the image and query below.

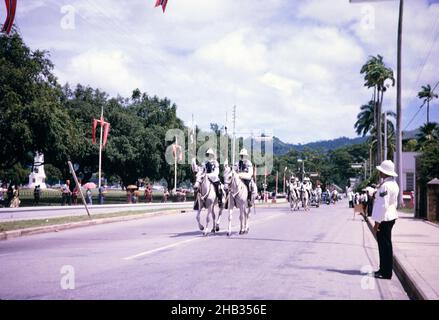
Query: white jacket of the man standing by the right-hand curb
372,177,399,222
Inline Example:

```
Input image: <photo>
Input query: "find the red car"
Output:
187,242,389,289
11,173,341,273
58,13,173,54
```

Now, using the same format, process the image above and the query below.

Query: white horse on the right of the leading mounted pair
224,164,256,236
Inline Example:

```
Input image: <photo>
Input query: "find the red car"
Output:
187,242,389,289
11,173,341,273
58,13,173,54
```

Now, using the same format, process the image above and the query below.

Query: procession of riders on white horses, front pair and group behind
192,148,333,235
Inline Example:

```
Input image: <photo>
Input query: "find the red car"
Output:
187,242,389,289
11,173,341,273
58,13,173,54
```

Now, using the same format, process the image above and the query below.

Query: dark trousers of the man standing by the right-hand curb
377,220,395,277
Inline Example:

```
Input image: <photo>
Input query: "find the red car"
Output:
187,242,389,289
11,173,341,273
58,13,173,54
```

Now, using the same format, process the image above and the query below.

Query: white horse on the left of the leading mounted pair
192,159,222,236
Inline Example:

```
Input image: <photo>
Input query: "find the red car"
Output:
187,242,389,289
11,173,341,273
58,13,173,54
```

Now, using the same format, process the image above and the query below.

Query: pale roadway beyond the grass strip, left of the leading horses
0,202,192,222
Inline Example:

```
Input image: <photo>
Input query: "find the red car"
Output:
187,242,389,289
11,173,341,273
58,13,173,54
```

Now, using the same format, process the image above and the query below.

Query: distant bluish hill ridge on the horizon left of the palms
273,137,367,155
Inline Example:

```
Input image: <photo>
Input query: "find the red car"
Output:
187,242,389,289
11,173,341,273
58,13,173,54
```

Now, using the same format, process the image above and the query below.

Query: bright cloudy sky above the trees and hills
10,0,439,143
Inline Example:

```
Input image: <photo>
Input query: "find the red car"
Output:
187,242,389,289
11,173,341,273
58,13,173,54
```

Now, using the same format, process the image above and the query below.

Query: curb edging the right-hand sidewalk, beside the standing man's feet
362,214,429,300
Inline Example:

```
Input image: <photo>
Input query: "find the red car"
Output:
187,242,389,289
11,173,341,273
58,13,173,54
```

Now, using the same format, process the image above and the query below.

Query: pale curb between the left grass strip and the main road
0,208,188,241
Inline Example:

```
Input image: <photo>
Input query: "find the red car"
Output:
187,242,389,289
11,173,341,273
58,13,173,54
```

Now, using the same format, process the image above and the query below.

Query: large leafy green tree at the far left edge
0,33,78,176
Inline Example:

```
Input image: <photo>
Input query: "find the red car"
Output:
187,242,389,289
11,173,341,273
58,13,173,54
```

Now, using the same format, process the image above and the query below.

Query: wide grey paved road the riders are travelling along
0,203,407,299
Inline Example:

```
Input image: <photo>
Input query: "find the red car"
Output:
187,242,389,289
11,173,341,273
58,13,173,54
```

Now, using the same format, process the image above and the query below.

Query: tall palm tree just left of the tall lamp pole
360,55,395,163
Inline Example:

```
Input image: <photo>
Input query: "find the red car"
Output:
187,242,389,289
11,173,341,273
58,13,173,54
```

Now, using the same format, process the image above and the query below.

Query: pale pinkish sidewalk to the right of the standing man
370,212,439,300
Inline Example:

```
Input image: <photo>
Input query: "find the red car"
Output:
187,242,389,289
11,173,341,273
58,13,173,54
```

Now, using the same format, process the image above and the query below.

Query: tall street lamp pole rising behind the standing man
349,0,404,207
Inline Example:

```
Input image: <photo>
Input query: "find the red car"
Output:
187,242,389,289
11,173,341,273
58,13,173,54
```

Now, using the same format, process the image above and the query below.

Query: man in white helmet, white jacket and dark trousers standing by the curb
372,160,399,279
